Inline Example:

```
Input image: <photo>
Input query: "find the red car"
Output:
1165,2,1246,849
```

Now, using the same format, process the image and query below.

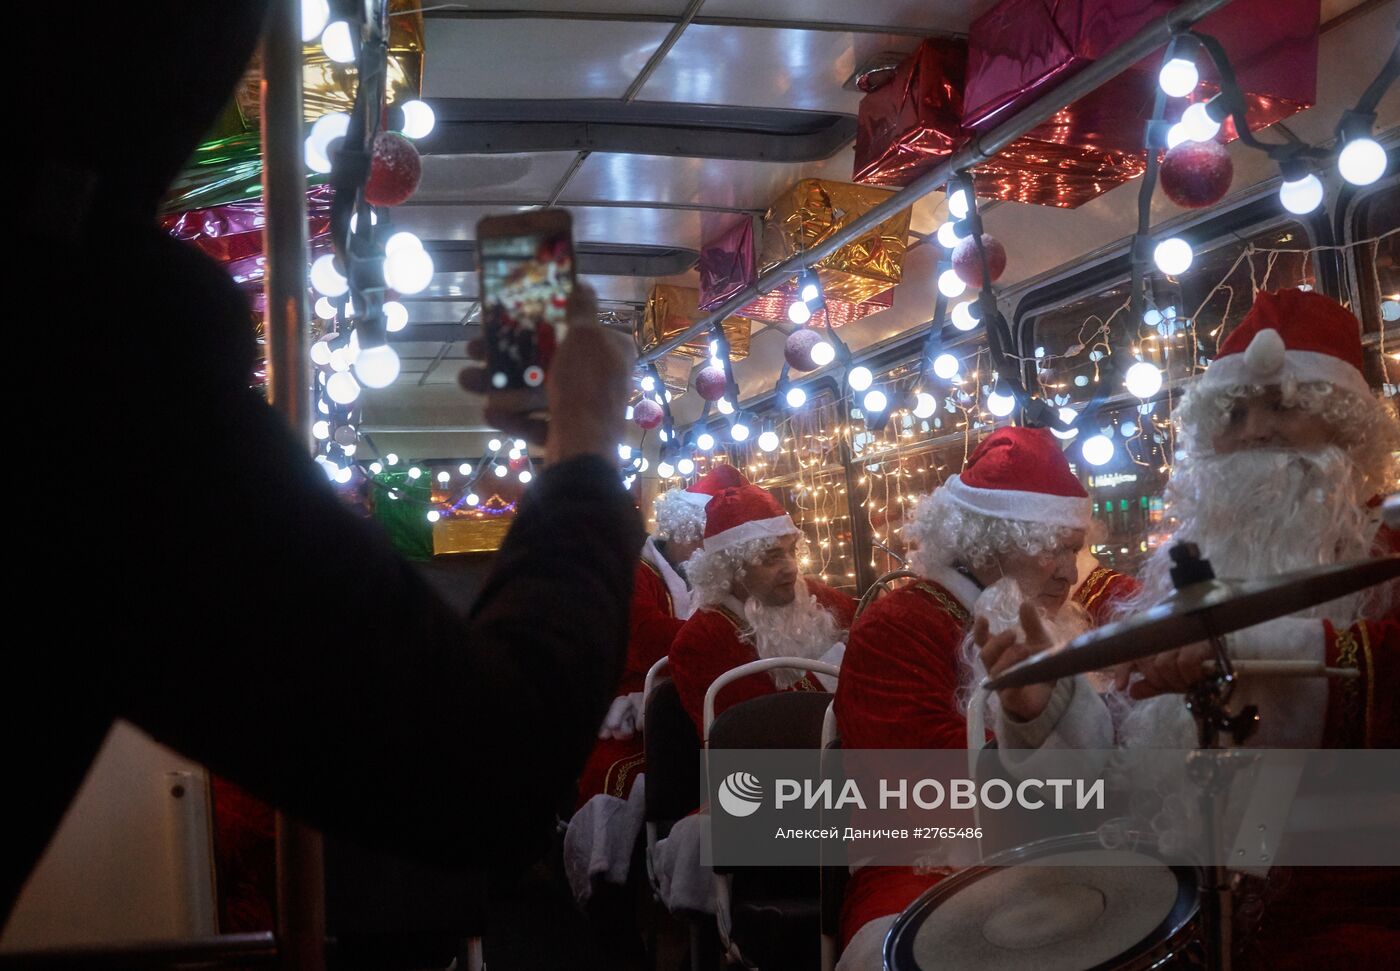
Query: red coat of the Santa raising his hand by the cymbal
836,567,1138,947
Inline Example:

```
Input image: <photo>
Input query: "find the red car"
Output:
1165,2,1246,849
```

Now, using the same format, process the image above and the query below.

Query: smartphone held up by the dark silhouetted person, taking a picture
476,208,574,389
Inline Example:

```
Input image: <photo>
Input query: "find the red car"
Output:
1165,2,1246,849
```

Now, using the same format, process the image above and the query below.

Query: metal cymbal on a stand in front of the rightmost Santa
983,554,1400,691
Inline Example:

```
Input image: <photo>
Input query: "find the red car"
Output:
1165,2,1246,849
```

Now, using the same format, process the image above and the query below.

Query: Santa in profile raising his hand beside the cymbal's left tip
836,428,1134,968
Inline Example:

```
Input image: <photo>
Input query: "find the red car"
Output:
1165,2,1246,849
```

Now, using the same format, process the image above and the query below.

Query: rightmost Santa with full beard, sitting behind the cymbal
981,290,1400,967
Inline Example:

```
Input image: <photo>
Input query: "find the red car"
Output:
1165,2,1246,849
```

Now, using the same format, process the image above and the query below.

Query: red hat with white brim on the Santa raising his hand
944,428,1092,529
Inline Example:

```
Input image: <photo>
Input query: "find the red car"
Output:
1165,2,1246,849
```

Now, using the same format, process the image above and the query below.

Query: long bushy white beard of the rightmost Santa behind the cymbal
1142,445,1373,624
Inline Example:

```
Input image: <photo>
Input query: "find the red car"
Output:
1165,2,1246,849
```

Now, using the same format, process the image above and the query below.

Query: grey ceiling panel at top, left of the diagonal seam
423,18,668,98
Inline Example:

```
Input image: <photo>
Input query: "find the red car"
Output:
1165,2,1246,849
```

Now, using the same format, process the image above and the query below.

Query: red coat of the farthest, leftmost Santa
578,560,685,806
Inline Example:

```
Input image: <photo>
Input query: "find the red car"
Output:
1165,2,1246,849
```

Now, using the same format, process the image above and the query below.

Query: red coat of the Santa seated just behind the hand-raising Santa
671,579,855,733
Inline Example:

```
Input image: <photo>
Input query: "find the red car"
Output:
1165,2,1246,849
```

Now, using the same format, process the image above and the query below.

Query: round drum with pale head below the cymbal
885,834,1201,971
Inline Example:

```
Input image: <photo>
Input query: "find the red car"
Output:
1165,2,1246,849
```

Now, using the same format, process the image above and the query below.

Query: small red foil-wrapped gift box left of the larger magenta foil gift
851,39,967,186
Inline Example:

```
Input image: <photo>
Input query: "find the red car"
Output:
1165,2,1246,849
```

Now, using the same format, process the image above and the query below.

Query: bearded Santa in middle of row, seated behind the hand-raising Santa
671,483,855,735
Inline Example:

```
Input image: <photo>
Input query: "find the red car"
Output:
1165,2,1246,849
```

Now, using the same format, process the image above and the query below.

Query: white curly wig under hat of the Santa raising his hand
904,488,1075,576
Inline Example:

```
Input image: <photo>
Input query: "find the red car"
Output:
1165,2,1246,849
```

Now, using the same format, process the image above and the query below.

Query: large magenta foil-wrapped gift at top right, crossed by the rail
962,0,1320,142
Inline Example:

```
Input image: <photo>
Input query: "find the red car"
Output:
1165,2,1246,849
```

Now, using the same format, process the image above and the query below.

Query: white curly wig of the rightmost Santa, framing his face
1172,379,1400,494
